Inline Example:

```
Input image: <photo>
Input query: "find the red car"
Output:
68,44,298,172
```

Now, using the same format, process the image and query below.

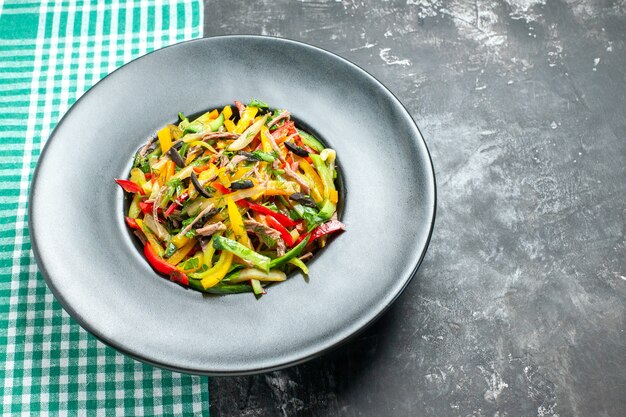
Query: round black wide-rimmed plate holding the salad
29,36,435,375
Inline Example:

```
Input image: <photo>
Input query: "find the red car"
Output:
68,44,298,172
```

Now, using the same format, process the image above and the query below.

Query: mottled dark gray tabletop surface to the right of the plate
205,0,626,417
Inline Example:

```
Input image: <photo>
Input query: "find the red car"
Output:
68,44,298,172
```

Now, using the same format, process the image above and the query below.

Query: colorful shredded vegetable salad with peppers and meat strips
115,100,344,295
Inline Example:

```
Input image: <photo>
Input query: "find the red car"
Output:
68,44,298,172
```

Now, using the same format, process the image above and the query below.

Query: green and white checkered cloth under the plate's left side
0,0,209,416
